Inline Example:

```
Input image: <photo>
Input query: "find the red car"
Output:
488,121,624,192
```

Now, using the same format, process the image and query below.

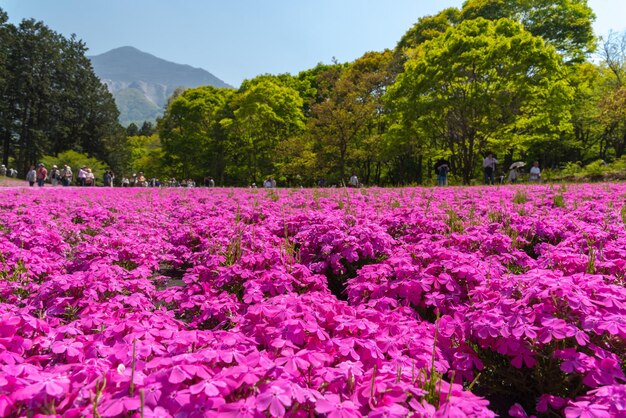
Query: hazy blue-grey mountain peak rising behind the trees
89,46,231,126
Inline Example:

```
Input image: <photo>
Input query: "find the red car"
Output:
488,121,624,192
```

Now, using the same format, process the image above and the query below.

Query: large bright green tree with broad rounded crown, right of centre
388,18,572,184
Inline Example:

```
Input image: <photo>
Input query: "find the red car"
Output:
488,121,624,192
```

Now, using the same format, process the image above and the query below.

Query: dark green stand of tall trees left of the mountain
0,9,127,177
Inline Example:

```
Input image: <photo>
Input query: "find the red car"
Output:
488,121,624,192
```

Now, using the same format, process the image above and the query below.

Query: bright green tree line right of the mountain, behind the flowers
154,0,626,185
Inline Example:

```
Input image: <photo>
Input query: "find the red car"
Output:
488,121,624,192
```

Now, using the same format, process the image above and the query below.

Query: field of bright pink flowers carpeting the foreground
0,184,626,418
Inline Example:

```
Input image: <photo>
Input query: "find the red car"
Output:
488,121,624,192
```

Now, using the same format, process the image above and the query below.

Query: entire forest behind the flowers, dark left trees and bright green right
0,0,626,186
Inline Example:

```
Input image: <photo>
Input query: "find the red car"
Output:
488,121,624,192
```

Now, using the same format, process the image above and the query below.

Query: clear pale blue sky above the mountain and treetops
0,0,626,86
